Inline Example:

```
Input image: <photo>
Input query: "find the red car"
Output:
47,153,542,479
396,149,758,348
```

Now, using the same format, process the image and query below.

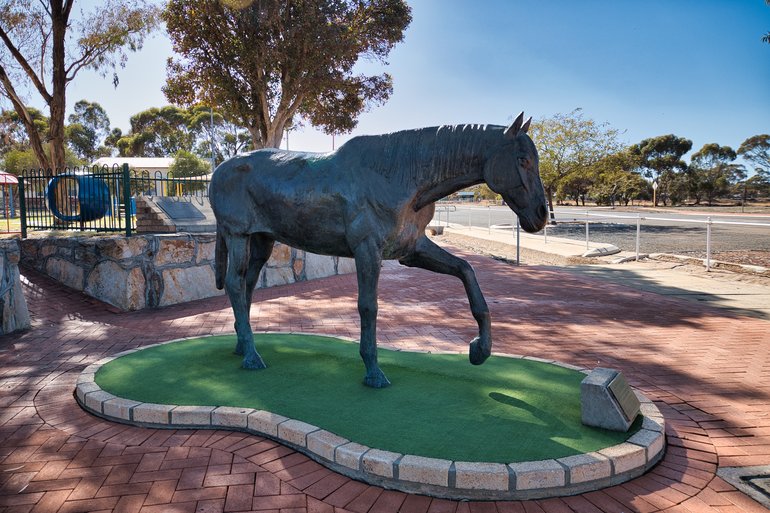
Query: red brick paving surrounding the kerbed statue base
0,246,770,513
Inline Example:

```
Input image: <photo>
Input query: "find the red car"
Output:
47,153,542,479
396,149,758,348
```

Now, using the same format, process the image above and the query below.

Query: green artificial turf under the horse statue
96,334,640,463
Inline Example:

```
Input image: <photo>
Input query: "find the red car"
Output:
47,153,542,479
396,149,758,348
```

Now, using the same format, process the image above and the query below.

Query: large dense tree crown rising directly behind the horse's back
163,0,411,148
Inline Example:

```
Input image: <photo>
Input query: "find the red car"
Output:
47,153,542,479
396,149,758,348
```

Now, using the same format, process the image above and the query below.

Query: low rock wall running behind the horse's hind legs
21,233,355,310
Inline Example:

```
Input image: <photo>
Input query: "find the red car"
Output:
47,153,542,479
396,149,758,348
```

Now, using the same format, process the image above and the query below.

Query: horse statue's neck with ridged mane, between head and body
337,125,504,185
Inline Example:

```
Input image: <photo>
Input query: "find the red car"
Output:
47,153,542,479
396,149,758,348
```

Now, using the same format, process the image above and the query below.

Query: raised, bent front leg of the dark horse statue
399,236,492,365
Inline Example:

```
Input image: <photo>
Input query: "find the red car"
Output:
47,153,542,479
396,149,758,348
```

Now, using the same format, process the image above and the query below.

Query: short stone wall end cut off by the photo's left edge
0,239,30,335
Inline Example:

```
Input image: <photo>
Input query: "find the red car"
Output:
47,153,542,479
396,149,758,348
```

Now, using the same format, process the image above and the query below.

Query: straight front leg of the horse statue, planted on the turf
355,241,390,388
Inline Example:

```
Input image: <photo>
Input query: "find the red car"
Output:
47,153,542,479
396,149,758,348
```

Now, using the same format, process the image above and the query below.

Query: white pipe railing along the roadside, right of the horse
435,204,770,271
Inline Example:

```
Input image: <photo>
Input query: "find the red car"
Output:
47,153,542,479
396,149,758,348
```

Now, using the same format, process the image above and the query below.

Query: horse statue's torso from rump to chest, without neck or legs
209,148,432,258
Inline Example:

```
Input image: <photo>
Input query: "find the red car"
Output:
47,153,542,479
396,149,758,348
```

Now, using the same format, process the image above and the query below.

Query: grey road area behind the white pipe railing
436,206,770,257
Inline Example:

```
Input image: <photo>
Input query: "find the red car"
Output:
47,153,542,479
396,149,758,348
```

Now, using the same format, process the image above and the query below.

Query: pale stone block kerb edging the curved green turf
75,333,666,500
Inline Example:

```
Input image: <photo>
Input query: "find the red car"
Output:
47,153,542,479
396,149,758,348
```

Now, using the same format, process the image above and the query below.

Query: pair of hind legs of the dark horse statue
225,235,273,369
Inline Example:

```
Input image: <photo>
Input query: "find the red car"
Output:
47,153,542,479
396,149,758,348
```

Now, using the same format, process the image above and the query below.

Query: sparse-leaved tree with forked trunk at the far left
0,0,158,172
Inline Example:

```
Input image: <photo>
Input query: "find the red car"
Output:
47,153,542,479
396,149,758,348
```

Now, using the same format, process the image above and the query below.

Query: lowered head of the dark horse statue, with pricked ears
484,112,548,233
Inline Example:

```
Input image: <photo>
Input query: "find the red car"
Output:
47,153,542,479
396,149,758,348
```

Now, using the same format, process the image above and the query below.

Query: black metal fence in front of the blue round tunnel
19,164,209,238
